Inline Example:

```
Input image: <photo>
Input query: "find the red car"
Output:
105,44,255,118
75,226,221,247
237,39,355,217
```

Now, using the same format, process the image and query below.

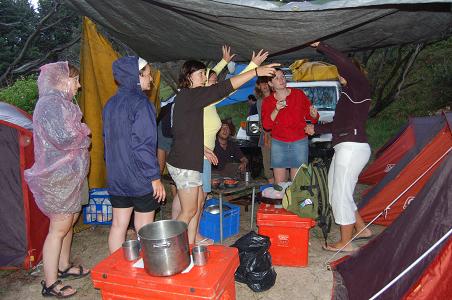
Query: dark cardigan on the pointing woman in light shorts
168,80,233,172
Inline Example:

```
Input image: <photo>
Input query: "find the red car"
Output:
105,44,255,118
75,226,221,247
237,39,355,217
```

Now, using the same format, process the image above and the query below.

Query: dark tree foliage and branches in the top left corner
0,0,81,85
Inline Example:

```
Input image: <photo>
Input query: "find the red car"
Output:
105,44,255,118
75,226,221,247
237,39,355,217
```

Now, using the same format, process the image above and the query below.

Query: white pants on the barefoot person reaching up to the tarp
328,142,370,225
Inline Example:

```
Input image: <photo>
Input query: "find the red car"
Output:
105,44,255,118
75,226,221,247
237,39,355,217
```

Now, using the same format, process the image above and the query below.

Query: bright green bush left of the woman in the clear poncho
0,76,38,114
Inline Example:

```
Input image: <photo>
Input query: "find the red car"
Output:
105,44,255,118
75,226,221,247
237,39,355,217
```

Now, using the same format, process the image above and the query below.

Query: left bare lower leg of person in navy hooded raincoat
108,207,133,254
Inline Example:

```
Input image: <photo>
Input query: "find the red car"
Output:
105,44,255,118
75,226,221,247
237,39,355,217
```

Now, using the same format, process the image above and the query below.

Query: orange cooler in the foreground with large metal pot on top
91,245,240,300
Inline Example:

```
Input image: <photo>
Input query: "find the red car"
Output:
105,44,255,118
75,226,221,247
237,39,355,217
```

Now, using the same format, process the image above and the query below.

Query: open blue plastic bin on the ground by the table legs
199,198,240,242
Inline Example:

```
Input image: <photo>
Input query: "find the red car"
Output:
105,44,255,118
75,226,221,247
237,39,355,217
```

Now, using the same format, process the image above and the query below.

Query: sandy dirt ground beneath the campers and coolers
0,184,382,300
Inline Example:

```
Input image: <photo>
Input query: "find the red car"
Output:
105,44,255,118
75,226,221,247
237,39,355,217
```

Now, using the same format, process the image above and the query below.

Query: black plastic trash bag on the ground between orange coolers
232,231,276,292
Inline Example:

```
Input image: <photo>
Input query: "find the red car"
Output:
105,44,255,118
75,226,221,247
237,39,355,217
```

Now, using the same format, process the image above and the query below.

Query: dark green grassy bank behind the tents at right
367,38,452,150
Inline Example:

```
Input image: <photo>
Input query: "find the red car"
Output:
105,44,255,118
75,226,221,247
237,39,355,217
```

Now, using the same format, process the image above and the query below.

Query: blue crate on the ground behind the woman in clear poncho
83,189,113,225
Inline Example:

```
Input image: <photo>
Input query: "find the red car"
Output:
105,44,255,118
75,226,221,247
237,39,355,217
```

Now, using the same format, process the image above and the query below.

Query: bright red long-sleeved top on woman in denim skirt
262,88,319,142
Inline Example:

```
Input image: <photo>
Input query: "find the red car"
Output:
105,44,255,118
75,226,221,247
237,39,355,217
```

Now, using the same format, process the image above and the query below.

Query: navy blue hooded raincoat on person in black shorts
102,56,160,197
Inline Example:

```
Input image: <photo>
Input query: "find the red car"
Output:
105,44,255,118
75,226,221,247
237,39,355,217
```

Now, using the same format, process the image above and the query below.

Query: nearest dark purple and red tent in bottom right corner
332,152,452,300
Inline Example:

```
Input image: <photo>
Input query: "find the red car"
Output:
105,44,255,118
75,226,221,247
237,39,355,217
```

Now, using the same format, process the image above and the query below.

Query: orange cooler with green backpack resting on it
257,203,315,267
